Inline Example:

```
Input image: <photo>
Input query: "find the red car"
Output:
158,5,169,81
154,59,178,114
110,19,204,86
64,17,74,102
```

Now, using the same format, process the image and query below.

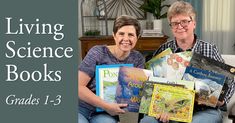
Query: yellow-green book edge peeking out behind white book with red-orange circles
145,48,172,69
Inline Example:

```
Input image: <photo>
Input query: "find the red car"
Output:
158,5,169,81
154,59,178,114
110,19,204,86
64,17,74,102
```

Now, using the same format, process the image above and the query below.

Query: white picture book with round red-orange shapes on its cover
151,51,192,79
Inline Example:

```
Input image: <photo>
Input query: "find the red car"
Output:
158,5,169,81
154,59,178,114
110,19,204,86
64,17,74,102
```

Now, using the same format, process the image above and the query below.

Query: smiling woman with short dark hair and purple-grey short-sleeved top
78,15,145,123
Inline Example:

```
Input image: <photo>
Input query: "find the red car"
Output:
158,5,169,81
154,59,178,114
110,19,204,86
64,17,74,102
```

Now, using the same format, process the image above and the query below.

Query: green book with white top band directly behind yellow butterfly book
139,76,194,114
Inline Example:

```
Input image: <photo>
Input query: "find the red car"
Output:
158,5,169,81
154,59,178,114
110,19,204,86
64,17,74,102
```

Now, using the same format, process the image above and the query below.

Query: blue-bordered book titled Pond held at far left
96,64,133,112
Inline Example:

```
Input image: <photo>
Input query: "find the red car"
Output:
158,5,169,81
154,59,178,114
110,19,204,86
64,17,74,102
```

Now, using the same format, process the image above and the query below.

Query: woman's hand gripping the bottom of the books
104,103,127,116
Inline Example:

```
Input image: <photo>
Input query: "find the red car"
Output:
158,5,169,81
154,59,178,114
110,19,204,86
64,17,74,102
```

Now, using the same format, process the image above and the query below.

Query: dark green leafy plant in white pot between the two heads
140,0,170,31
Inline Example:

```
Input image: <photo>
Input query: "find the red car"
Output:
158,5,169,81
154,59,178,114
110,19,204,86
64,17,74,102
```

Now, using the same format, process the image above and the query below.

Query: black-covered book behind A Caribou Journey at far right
190,53,235,101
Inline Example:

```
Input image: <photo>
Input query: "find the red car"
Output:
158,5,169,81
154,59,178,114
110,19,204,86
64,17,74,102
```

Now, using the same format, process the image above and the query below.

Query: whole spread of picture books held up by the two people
96,49,235,122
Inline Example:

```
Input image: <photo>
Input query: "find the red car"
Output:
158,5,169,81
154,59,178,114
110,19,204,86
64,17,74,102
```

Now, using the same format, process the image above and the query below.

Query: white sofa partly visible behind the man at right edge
222,54,235,123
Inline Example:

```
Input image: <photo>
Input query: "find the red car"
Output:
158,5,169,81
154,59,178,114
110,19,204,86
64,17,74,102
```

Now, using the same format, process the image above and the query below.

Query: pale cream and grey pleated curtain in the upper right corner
202,0,235,54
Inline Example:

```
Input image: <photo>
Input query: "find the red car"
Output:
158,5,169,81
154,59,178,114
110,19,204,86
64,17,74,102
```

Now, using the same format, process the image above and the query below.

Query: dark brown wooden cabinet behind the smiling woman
79,36,168,58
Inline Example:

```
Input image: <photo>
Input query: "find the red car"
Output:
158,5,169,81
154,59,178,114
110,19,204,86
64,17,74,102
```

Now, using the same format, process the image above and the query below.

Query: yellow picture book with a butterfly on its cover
148,84,195,122
